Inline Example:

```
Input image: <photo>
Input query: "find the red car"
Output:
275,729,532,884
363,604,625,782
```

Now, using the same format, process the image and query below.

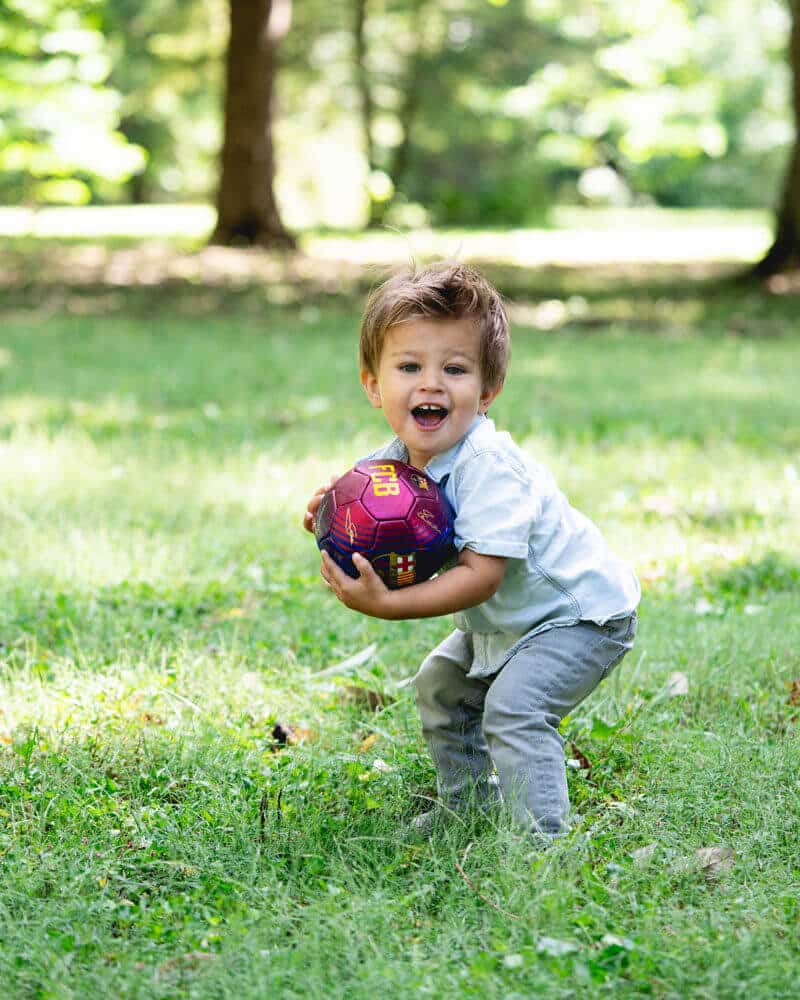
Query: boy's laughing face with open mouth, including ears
361,319,500,469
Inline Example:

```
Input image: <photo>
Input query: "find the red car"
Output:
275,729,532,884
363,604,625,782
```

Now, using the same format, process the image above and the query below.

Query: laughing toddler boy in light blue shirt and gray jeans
304,263,640,836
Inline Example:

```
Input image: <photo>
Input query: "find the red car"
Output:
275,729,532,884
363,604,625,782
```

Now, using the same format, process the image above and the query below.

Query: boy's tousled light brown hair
359,261,511,389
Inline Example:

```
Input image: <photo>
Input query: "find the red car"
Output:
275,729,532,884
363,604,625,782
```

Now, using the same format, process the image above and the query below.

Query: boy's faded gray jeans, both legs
414,614,636,834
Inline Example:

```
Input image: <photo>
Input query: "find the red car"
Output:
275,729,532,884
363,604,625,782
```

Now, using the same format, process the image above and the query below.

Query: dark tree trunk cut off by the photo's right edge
752,0,800,278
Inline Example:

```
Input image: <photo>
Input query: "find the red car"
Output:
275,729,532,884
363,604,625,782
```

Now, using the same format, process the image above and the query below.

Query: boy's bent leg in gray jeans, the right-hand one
483,615,636,835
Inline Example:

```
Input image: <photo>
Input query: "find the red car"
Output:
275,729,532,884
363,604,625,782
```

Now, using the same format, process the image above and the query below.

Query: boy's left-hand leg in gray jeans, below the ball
414,629,496,810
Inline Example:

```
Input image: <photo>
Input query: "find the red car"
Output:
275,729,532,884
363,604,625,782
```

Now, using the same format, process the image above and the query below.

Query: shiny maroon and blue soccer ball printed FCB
315,459,454,590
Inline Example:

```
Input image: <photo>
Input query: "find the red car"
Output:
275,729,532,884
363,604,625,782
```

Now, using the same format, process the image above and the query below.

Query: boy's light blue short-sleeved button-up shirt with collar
368,415,641,677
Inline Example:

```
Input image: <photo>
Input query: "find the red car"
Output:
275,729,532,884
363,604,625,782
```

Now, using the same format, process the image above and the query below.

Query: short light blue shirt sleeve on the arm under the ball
455,453,541,559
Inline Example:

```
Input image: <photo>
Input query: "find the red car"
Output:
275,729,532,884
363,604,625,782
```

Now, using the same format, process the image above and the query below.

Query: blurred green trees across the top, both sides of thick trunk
0,0,797,266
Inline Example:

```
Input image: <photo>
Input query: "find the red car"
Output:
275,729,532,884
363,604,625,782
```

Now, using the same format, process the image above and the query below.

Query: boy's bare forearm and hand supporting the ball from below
321,549,506,619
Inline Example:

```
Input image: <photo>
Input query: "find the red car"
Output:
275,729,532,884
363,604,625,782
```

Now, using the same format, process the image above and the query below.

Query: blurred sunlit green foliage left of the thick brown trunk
0,0,224,204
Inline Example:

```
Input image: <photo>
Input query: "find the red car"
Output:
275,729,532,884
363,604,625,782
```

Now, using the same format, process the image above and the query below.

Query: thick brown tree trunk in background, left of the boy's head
211,0,295,249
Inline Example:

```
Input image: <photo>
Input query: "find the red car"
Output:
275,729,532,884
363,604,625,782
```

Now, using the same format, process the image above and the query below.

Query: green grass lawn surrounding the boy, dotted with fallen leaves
0,223,800,1000
